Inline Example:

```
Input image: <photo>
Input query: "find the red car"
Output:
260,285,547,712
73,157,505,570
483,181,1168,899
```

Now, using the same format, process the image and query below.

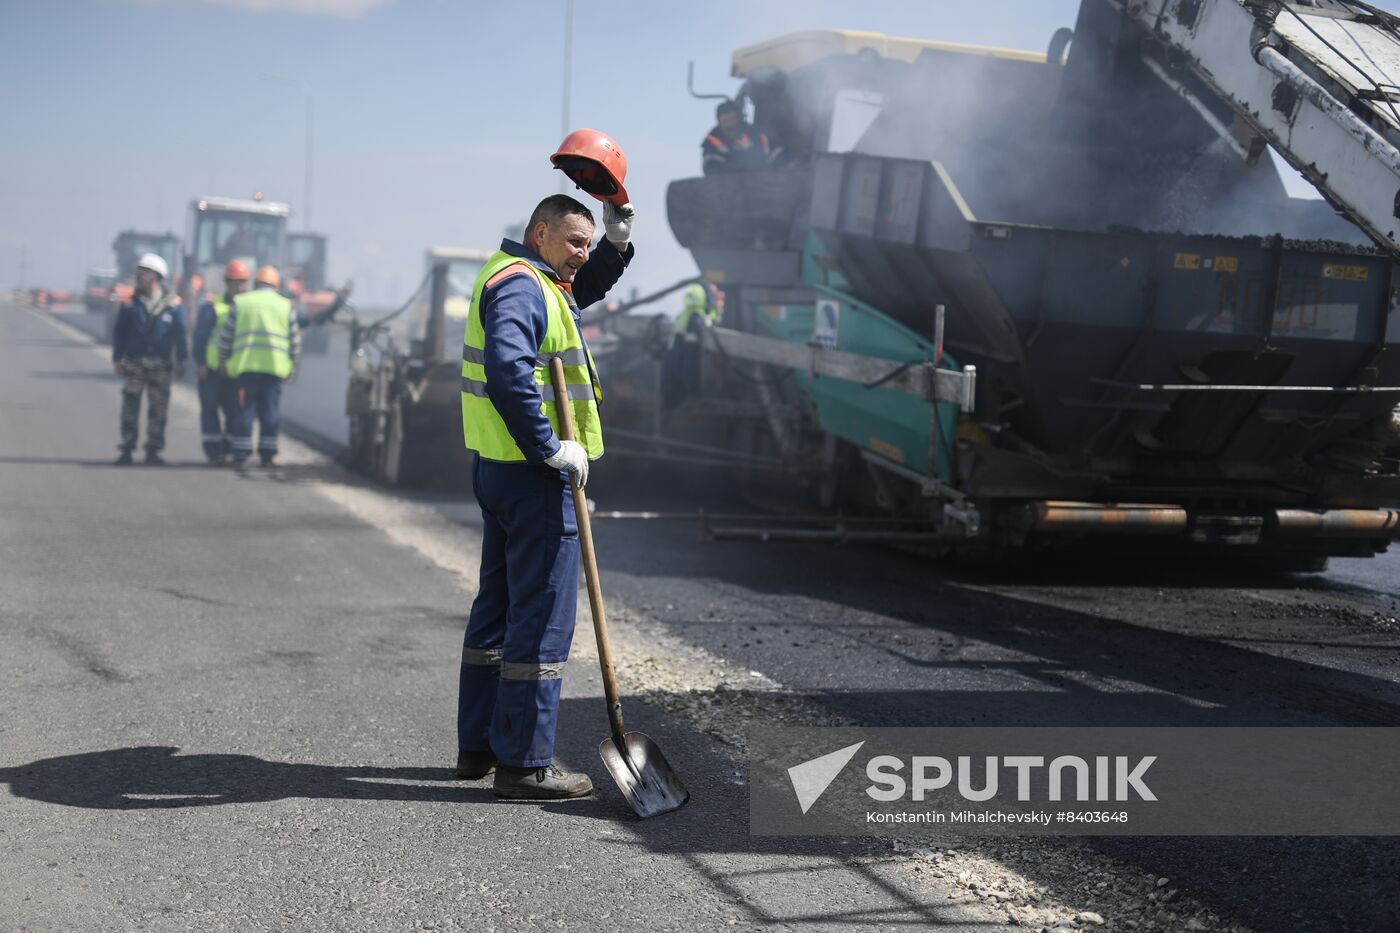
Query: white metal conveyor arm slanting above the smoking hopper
1106,0,1400,258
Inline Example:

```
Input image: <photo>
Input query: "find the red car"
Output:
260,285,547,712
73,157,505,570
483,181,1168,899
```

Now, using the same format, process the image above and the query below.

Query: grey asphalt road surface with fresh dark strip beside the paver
10,305,1400,930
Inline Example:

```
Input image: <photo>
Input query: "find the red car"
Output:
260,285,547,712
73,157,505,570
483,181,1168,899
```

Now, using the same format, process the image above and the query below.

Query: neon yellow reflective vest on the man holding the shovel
462,251,603,462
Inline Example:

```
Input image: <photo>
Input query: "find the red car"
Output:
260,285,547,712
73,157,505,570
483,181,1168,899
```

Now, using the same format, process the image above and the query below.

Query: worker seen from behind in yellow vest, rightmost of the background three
218,266,301,469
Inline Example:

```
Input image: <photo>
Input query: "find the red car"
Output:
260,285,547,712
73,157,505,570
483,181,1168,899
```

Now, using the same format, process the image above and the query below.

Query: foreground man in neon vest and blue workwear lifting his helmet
456,195,636,800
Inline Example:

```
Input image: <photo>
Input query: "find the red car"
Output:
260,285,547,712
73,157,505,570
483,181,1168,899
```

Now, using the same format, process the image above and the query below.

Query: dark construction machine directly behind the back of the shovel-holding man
346,247,490,486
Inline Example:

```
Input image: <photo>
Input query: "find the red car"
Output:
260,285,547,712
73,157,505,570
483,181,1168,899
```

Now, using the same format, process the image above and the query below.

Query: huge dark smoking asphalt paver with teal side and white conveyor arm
627,0,1400,569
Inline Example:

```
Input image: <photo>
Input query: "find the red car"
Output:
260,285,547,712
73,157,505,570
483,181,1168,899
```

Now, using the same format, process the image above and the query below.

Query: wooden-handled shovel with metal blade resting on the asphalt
549,356,690,820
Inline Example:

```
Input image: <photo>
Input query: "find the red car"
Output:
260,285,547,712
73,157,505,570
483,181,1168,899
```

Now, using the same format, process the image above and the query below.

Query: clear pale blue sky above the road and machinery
0,0,1396,303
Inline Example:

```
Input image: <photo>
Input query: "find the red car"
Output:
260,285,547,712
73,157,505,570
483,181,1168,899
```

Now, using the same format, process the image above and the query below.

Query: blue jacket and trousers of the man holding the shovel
456,233,636,768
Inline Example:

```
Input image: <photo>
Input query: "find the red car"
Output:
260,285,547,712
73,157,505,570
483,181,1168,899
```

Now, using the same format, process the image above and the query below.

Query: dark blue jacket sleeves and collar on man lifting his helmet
482,240,637,464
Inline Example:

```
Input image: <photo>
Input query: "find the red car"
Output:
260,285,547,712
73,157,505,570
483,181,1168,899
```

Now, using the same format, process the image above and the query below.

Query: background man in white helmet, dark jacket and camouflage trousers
112,252,189,467
